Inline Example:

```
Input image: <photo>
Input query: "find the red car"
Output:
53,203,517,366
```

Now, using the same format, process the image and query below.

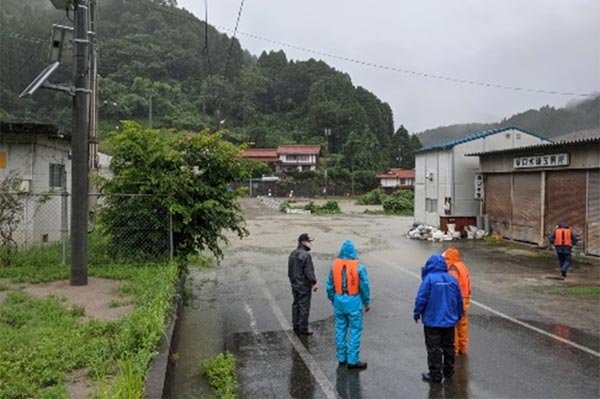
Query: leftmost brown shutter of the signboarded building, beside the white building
483,174,512,237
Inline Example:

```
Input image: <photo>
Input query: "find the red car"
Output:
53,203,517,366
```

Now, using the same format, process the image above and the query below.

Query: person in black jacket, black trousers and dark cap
288,233,319,335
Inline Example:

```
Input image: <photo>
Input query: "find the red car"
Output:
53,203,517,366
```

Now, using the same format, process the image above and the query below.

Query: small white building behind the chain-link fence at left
0,122,71,246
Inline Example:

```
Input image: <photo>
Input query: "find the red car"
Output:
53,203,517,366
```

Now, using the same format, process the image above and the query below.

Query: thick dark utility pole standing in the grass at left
70,0,91,285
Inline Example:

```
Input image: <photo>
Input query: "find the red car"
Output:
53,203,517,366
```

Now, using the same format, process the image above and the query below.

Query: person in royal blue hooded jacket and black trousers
413,254,464,383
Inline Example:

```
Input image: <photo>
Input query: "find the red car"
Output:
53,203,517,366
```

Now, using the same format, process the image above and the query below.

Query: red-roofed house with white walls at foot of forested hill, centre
243,144,321,173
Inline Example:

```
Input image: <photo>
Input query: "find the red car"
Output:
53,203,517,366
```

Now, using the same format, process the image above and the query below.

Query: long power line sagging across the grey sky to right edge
215,25,594,97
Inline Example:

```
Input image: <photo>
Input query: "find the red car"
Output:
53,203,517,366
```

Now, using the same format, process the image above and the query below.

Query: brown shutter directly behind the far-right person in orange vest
545,170,586,238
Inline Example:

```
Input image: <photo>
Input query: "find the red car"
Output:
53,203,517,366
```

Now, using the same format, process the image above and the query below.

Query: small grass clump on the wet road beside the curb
200,352,238,399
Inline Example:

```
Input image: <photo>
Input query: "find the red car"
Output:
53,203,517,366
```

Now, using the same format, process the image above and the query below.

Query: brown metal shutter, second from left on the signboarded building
511,173,542,244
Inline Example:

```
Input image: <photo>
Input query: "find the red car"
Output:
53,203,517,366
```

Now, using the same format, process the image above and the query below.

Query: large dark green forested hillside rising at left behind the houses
0,0,418,170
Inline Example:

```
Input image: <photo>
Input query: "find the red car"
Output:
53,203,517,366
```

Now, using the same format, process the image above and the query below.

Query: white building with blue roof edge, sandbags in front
415,126,550,227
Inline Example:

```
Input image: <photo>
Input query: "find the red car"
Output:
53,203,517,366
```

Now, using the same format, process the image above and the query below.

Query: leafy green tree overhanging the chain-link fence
102,121,252,257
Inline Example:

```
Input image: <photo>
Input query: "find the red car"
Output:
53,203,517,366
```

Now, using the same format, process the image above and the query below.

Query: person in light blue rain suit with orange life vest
326,240,371,370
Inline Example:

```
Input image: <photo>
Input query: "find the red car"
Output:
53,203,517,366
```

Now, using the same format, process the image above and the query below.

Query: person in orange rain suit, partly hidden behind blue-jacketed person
443,247,471,355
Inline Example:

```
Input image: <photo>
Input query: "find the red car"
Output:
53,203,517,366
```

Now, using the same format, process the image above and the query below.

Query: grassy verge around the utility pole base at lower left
0,247,179,399
